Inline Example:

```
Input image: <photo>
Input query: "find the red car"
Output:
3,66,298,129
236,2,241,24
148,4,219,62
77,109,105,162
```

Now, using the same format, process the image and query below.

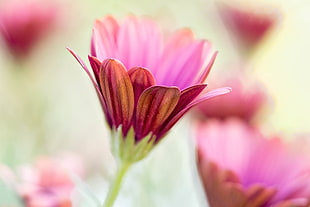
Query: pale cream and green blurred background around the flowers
0,0,310,207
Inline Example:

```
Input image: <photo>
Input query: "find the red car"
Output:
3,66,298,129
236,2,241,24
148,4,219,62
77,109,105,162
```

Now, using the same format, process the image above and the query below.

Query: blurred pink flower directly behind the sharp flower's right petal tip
196,76,267,122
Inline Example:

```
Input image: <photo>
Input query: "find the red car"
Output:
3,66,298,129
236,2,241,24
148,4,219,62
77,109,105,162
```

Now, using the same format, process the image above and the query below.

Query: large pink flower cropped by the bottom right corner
197,120,310,207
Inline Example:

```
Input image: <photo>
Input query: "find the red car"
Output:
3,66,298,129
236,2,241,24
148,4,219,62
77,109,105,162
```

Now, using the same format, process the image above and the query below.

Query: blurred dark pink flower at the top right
219,4,277,52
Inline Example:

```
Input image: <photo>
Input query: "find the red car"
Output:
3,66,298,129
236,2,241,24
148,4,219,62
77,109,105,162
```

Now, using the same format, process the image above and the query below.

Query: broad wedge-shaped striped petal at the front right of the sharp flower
134,86,181,141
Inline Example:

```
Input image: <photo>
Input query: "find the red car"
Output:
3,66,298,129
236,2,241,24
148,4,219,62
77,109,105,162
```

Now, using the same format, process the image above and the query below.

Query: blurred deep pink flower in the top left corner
0,0,59,59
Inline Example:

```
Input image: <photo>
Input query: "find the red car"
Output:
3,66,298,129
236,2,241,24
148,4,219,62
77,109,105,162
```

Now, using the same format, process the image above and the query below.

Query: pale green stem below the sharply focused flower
103,163,131,207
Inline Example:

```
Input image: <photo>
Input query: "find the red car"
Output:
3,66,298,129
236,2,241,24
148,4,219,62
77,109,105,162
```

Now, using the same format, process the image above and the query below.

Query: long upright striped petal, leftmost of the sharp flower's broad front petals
99,59,134,135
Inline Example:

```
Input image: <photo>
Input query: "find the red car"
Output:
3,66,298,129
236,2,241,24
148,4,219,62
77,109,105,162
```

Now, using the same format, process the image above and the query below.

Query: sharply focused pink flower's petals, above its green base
70,16,230,142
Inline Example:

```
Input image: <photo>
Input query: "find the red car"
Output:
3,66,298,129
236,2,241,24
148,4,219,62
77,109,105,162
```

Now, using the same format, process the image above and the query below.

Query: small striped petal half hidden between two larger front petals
128,67,155,105
